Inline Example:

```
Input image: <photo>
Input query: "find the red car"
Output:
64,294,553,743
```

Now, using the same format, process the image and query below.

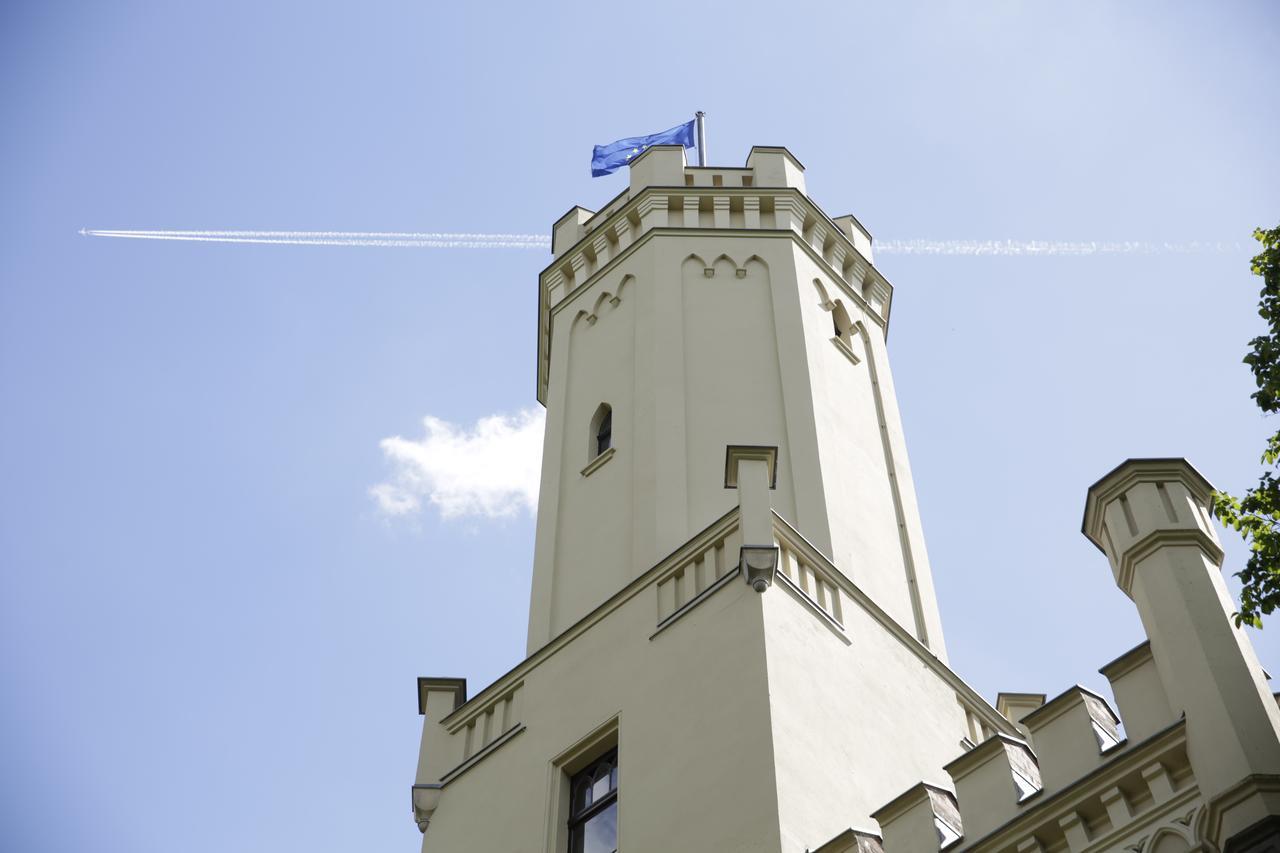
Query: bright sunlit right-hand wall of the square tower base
763,571,965,853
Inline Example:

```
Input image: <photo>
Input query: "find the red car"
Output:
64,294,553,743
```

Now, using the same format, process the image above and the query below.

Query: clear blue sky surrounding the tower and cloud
0,1,1280,853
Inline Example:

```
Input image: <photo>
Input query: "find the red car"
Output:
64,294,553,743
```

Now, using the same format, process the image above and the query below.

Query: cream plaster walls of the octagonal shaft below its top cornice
529,208,946,660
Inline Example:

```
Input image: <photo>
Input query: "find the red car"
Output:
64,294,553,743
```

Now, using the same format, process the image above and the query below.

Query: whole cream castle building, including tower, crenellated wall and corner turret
412,146,1280,853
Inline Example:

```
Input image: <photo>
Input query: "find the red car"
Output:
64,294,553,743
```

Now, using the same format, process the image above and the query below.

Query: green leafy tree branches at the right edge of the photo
1213,225,1280,628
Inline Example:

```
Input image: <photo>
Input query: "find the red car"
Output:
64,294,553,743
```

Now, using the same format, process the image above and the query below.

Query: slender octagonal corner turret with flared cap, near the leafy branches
1084,459,1280,849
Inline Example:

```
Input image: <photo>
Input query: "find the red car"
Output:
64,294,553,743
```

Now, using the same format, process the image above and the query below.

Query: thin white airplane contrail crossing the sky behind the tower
81,228,1243,257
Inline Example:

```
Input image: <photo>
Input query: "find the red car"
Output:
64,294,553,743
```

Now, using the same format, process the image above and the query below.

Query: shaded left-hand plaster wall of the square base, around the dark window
422,550,781,853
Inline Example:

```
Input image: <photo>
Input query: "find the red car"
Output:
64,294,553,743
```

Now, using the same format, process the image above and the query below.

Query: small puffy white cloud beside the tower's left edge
369,409,544,519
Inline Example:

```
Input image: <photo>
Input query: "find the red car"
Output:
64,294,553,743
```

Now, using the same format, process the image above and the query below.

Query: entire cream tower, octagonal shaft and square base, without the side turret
413,146,1019,853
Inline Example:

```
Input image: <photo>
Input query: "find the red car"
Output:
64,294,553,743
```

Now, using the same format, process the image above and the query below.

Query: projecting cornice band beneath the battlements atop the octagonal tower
536,186,893,405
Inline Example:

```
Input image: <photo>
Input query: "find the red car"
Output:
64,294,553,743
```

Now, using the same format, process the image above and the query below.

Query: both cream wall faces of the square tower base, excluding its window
419,504,988,853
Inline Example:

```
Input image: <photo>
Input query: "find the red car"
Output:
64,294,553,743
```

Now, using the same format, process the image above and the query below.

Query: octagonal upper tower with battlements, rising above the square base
529,146,946,660
